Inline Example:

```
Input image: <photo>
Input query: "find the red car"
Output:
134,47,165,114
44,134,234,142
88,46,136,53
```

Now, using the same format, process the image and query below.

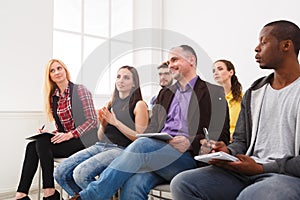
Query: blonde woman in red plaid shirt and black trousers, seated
15,59,97,200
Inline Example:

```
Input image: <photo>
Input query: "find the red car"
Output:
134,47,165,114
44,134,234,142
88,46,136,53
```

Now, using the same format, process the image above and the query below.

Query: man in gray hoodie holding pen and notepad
171,20,300,200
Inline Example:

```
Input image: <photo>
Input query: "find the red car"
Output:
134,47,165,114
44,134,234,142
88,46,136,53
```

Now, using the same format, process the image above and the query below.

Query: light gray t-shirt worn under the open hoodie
252,78,300,164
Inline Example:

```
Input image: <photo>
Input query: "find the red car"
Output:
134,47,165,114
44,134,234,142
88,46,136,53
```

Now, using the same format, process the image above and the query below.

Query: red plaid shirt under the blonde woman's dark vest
53,85,97,138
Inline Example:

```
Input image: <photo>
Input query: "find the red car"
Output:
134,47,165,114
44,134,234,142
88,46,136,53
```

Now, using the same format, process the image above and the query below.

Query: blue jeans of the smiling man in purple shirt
79,138,197,200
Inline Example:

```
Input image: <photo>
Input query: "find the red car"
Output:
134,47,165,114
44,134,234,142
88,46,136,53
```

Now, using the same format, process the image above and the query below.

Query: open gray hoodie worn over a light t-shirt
228,73,300,177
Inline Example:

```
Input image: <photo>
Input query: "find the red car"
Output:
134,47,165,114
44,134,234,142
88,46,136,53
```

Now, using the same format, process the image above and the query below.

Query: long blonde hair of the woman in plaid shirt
44,59,71,121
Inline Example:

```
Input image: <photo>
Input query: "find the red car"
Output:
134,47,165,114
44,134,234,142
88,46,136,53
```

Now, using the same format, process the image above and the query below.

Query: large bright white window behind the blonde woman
53,0,133,96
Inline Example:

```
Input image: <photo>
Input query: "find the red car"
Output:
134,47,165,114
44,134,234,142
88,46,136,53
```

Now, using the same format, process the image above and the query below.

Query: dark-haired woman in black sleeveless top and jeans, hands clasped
54,66,148,196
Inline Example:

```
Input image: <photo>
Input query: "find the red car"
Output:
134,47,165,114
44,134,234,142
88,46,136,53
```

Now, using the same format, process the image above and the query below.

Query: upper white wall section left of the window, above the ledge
0,0,53,111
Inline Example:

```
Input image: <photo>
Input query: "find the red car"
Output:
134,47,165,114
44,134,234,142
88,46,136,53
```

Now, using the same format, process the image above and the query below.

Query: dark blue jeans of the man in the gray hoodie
171,166,300,200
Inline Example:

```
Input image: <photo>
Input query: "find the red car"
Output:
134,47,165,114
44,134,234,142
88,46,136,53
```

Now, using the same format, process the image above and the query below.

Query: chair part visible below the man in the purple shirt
149,183,172,200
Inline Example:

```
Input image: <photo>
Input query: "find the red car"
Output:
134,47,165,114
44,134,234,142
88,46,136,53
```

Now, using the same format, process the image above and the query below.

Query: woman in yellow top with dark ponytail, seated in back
213,60,243,142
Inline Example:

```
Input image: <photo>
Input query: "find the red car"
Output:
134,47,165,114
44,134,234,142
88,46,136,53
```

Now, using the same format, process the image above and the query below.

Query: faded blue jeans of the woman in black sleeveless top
54,142,123,196
